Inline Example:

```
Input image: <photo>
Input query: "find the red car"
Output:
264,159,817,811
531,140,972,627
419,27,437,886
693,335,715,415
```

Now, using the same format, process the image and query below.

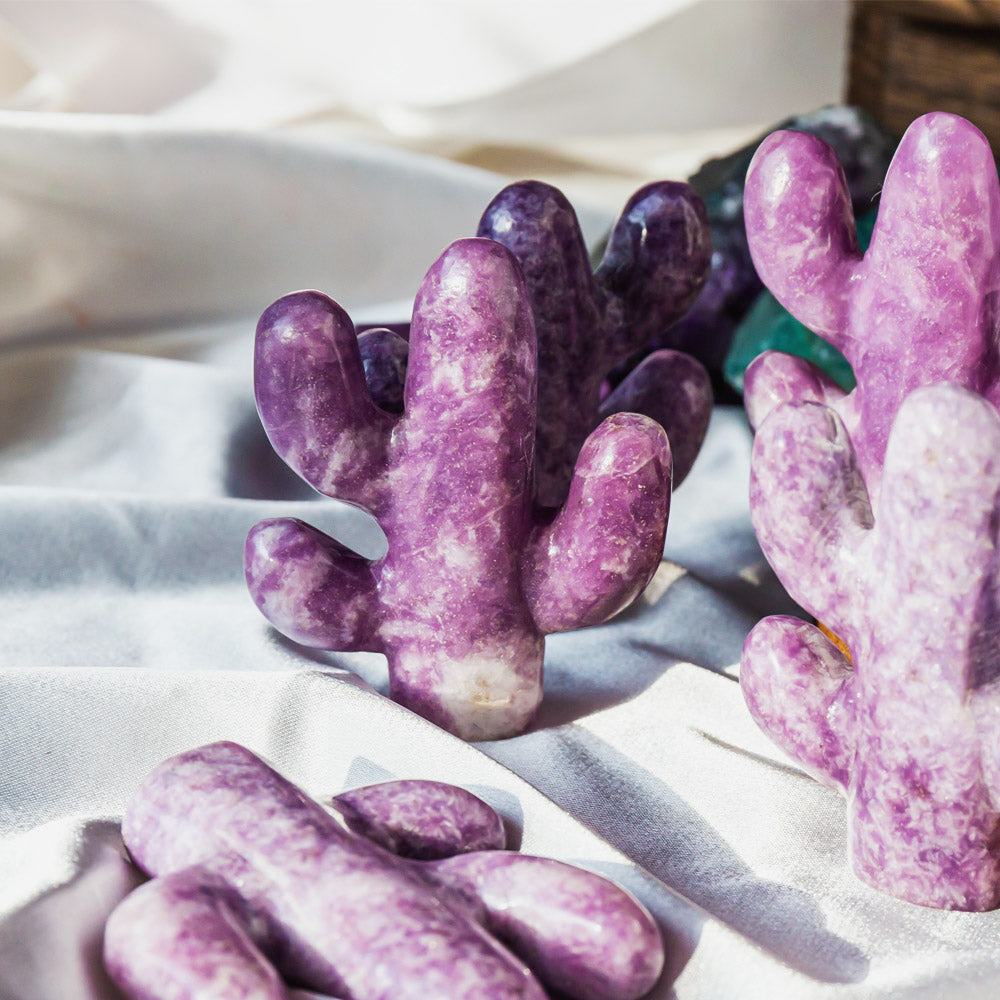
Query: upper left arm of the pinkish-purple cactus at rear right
743,131,861,352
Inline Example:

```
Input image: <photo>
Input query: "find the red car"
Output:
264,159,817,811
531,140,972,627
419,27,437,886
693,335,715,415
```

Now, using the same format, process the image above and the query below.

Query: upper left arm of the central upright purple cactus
254,292,396,512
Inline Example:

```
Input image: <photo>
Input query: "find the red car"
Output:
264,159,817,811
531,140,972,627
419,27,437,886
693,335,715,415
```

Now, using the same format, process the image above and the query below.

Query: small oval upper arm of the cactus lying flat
331,780,507,861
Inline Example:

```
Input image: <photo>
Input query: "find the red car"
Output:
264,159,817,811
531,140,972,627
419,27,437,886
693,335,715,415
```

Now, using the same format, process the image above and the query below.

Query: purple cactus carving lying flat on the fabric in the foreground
104,743,664,1000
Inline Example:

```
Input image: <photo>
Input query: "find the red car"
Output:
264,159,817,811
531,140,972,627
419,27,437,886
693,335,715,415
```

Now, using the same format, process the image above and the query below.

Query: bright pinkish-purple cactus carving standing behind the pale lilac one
744,112,1000,496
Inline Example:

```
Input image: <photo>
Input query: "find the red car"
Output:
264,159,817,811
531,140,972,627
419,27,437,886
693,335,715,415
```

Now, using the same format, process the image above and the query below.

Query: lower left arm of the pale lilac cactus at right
740,615,856,788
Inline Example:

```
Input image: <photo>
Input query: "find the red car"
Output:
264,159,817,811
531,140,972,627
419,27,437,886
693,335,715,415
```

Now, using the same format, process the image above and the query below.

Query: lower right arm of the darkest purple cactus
599,350,712,489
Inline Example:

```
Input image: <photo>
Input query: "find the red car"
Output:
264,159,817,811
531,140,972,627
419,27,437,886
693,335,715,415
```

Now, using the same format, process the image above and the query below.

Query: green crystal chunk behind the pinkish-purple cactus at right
722,210,878,392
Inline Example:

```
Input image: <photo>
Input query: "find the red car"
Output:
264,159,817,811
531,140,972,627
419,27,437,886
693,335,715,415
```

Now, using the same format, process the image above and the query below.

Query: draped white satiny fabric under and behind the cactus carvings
0,0,1000,1000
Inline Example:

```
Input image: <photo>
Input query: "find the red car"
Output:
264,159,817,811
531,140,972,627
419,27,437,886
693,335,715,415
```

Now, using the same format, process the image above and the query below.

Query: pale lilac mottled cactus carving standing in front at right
741,385,1000,910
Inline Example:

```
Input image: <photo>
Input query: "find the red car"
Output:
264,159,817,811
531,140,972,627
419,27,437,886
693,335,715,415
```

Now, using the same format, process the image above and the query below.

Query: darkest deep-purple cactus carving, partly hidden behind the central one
478,181,712,506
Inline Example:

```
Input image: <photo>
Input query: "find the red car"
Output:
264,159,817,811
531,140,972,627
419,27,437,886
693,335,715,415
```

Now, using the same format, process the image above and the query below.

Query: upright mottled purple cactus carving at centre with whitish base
245,239,671,739
